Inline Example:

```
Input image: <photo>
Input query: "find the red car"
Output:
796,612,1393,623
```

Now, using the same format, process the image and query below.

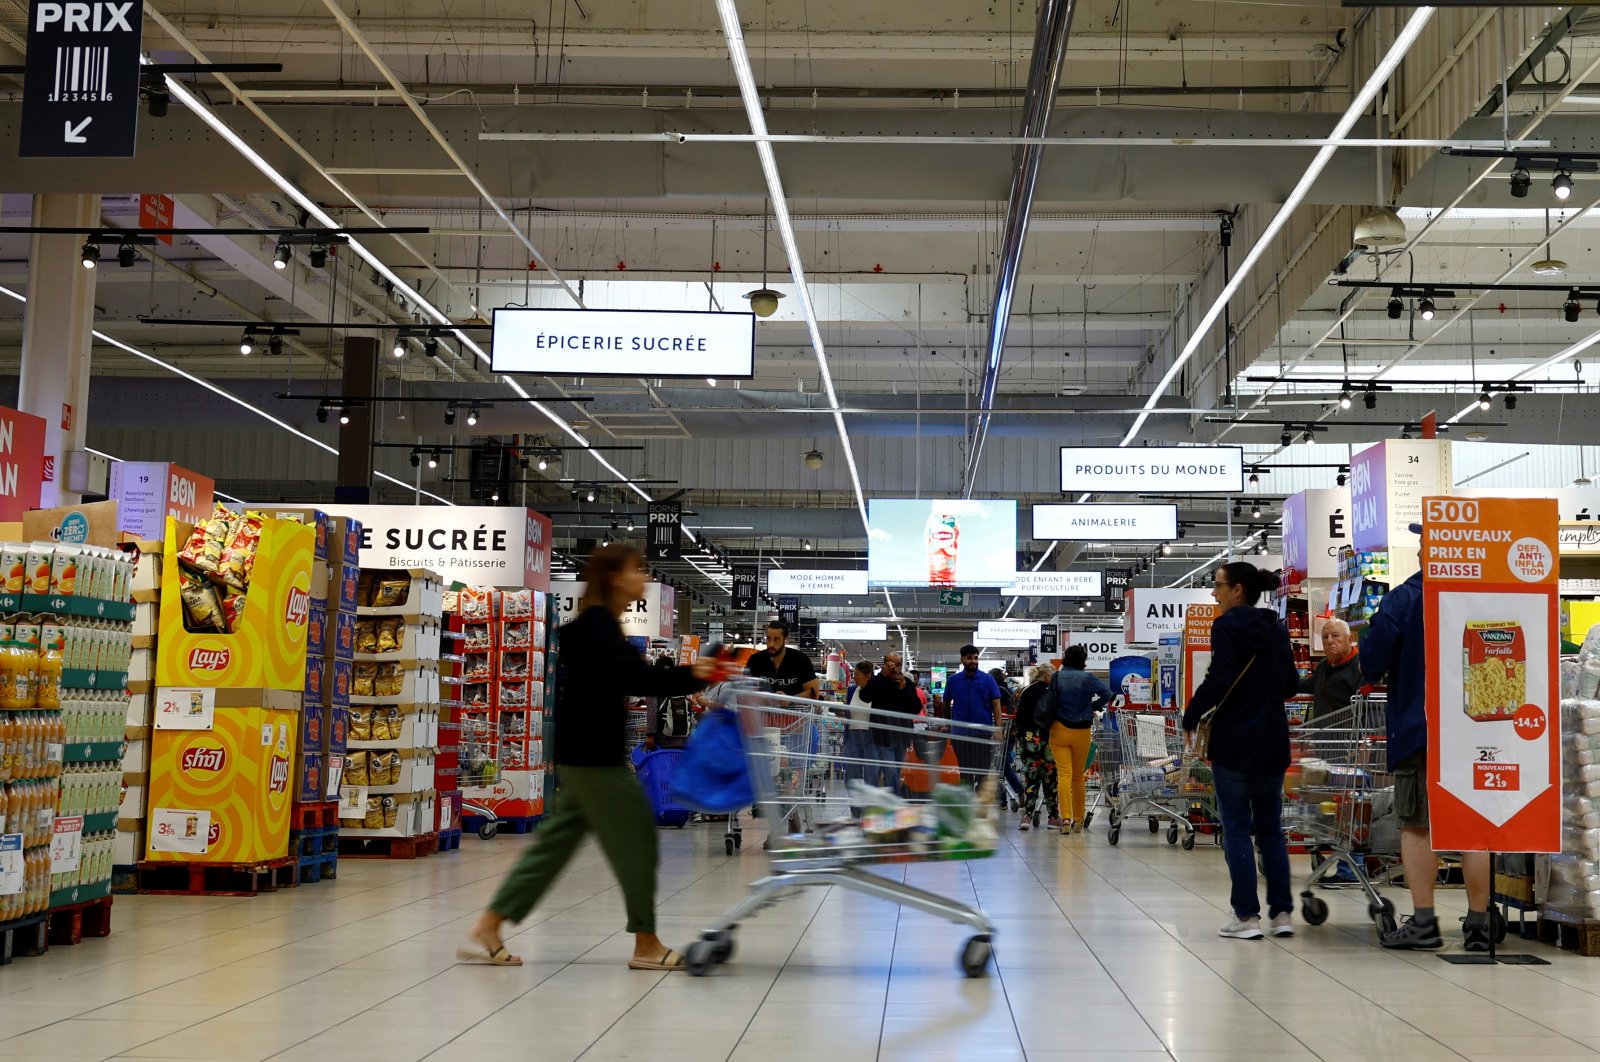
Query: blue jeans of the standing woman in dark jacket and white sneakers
1211,765,1294,918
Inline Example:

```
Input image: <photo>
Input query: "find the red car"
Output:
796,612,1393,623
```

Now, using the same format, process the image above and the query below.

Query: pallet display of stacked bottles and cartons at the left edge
0,542,133,961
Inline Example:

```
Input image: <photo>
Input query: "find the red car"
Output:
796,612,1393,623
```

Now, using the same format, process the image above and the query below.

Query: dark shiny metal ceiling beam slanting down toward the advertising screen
962,0,1077,497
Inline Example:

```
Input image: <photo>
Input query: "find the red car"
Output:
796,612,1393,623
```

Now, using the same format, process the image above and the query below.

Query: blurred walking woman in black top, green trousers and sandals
458,544,722,971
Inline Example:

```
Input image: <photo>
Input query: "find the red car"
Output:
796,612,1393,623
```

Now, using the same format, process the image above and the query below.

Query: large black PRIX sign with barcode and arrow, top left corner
18,0,144,158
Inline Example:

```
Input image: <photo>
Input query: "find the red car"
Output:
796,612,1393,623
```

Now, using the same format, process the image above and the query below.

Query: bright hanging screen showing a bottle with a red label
867,497,1016,587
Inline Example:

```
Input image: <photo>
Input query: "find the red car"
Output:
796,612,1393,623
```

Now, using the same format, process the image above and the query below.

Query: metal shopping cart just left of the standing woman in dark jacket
1094,709,1213,851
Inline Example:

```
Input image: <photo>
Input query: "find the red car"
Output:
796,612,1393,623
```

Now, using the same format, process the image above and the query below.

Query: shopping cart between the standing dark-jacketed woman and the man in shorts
1285,694,1400,932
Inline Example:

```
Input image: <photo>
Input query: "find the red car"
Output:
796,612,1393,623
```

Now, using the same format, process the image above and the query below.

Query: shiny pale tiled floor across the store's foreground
0,824,1600,1062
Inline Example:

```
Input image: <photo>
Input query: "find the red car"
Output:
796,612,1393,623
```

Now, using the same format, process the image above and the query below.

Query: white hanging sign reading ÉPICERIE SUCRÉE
490,307,755,379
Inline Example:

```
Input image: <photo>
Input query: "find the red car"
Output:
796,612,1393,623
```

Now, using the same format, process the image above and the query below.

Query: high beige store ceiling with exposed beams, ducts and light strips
0,0,1600,645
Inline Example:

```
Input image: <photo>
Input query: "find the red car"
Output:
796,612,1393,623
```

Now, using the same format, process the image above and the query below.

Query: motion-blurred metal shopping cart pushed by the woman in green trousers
685,680,1005,977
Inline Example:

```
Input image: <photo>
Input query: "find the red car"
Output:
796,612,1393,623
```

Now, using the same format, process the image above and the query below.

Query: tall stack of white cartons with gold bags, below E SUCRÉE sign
339,569,443,857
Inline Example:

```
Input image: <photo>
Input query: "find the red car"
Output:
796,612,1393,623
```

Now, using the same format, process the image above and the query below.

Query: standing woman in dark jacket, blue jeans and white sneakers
1184,561,1299,940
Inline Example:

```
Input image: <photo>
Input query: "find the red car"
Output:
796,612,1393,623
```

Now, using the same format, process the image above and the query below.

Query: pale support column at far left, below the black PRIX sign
18,195,99,509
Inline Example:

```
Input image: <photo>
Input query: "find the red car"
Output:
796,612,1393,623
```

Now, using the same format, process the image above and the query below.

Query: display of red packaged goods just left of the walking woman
456,590,552,827
